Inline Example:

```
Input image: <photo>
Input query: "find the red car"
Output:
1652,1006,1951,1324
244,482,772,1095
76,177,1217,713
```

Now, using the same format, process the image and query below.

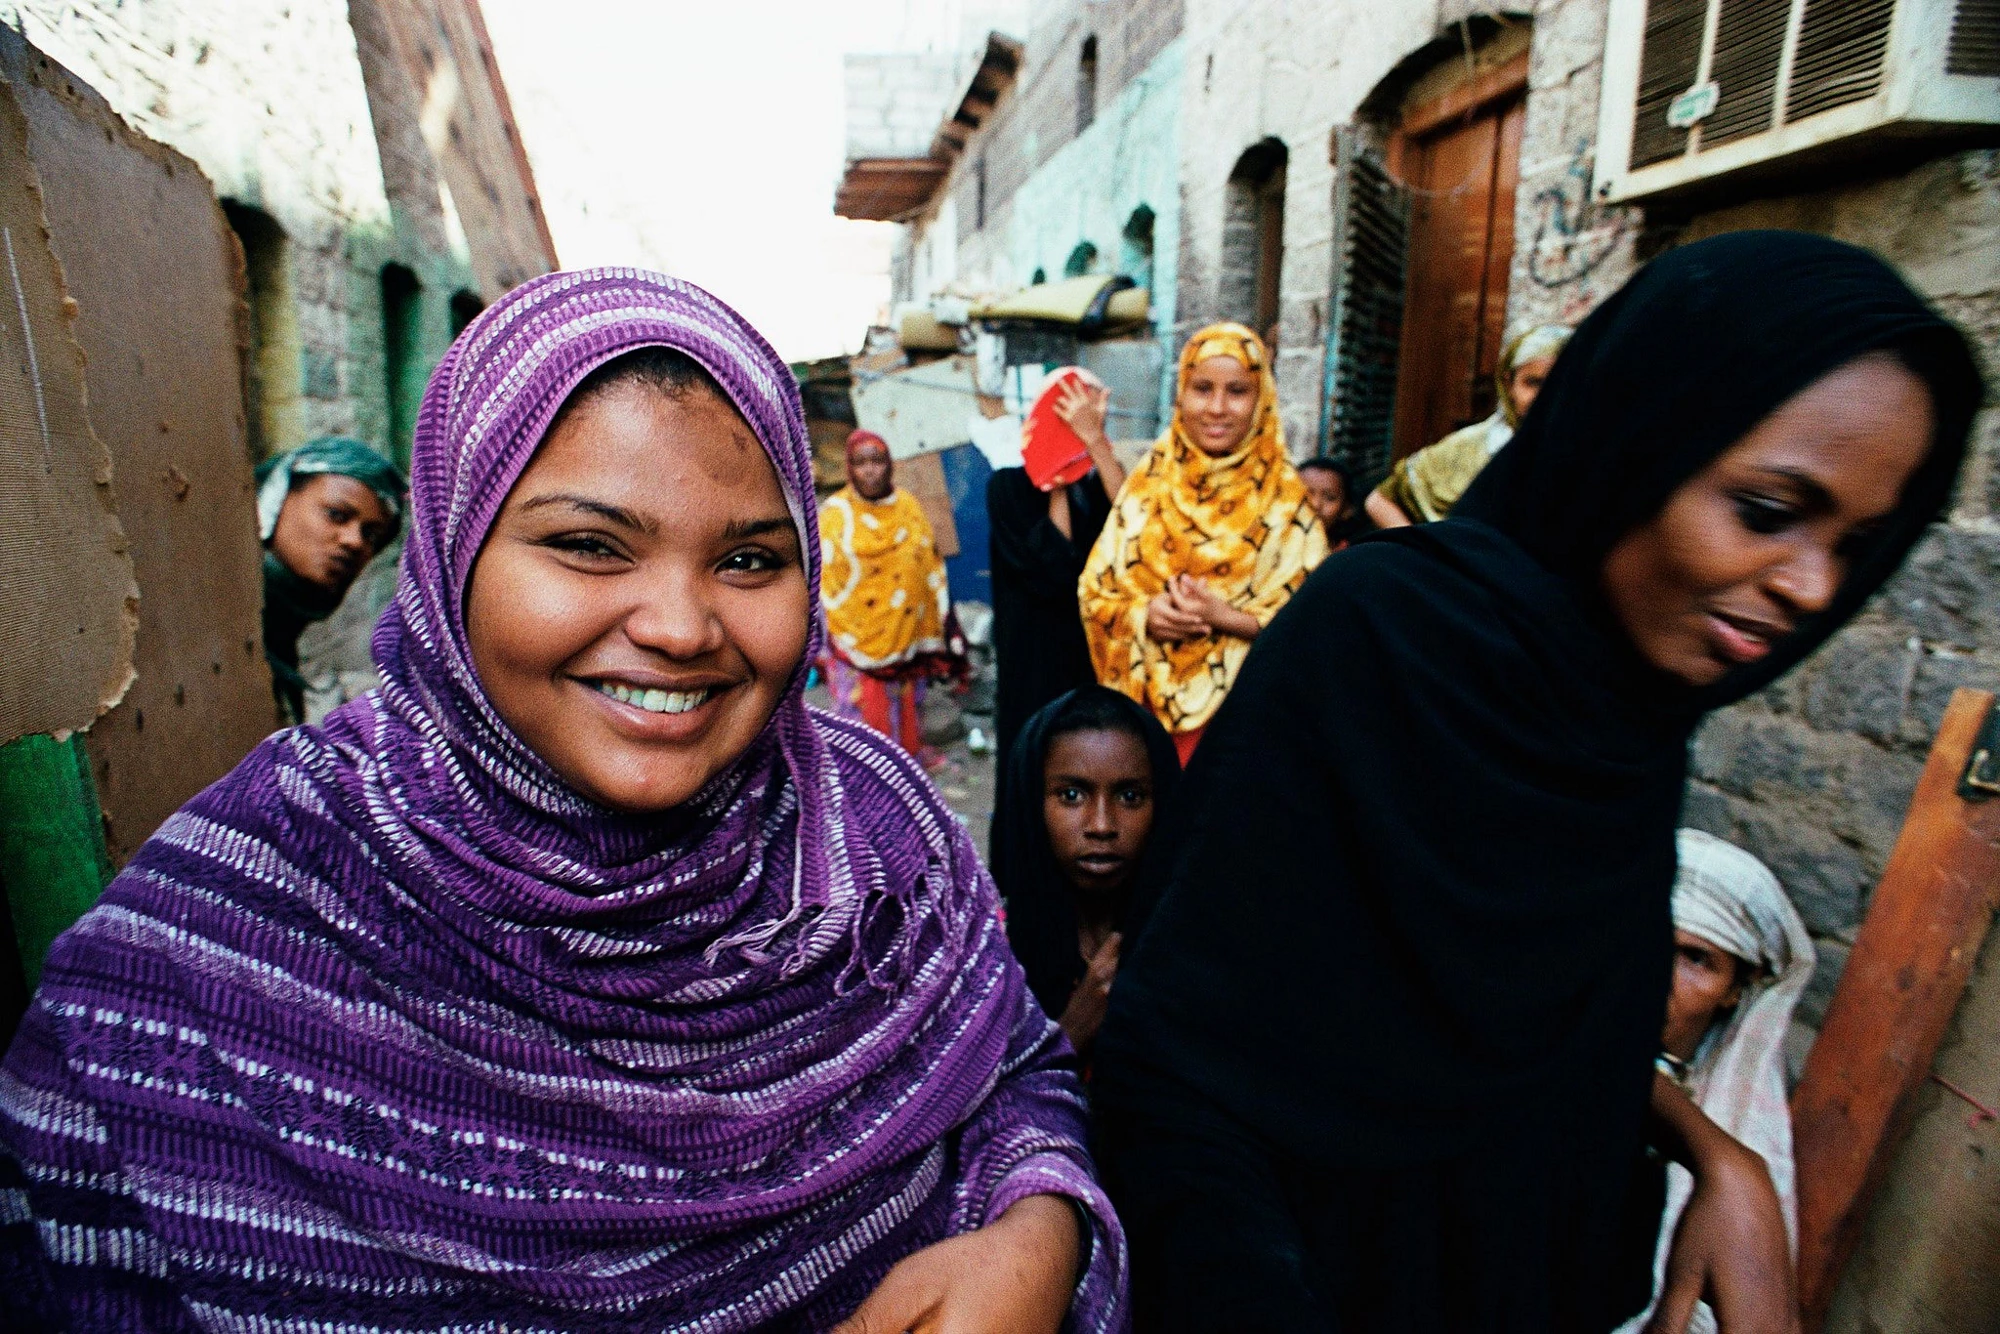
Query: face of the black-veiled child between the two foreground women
1042,732,1152,894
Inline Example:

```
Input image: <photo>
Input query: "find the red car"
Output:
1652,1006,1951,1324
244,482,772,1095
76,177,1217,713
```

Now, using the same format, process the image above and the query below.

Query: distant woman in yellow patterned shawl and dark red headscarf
820,430,964,754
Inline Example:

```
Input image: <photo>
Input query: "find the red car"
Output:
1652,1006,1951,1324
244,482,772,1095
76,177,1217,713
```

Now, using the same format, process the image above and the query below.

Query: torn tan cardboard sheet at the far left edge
0,70,138,744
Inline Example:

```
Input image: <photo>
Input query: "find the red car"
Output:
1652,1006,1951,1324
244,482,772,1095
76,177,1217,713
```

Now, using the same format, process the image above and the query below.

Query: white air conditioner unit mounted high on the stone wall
1596,0,2000,202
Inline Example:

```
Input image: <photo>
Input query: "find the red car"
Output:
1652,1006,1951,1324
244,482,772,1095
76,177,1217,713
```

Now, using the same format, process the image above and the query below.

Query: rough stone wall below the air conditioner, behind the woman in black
1508,0,2000,1060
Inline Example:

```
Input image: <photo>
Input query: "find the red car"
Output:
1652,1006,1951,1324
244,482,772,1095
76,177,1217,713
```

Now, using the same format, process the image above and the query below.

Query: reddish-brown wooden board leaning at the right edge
1792,690,2000,1334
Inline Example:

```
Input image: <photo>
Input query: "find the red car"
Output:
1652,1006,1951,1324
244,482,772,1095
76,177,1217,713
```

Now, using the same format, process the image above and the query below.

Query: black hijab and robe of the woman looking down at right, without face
1094,232,1982,1328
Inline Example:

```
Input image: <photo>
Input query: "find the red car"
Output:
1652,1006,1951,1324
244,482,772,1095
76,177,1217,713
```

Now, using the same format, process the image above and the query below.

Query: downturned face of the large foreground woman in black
1602,354,1932,686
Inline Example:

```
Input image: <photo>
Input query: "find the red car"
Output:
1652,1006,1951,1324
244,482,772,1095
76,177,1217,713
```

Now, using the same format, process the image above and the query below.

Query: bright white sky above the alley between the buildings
482,0,1016,360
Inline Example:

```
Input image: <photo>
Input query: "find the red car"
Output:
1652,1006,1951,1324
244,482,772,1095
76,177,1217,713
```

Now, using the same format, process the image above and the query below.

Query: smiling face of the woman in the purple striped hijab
466,382,810,812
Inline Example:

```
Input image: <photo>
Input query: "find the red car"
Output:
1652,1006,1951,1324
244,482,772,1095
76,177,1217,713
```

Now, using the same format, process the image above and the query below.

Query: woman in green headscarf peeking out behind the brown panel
256,436,408,722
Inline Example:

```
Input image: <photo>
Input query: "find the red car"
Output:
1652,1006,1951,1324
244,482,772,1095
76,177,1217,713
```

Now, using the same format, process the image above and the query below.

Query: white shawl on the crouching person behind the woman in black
1616,830,1812,1334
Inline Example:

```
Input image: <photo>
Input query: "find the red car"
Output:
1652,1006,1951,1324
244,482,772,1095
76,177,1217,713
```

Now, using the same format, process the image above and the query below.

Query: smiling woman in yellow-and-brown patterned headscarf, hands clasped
1076,324,1326,760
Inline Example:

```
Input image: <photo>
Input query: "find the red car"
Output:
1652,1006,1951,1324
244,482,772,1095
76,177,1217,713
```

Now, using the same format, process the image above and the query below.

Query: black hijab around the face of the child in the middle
992,686,1180,1018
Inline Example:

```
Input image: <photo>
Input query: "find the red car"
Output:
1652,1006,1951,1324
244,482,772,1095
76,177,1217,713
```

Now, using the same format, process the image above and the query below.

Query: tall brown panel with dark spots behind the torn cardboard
0,30,274,864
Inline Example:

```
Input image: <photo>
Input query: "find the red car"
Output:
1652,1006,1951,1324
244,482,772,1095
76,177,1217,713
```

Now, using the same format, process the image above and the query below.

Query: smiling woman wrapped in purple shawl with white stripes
0,270,1126,1334
